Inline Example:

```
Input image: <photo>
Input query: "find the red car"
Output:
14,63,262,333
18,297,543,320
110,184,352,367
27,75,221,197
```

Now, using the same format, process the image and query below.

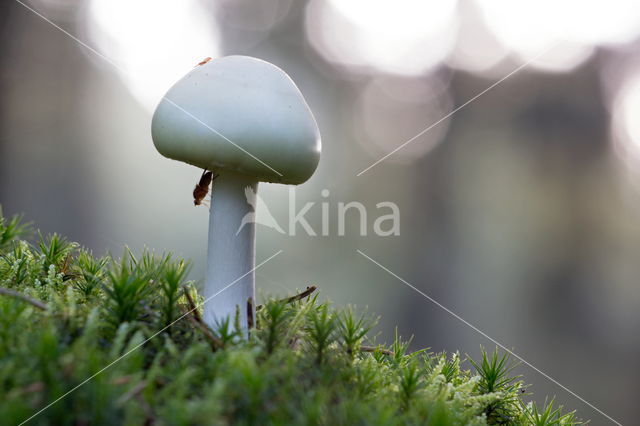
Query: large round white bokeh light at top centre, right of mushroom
306,0,457,75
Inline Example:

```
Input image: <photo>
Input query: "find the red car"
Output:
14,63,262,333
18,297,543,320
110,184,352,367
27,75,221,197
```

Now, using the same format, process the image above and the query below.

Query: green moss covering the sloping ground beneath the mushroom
0,211,578,425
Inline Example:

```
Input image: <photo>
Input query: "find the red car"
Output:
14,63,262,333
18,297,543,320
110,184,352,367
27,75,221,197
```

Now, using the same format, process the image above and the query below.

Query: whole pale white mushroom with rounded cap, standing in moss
151,56,320,330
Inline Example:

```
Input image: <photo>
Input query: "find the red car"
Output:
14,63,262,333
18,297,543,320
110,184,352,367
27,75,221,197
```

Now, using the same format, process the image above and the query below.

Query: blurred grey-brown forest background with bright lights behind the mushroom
0,0,640,424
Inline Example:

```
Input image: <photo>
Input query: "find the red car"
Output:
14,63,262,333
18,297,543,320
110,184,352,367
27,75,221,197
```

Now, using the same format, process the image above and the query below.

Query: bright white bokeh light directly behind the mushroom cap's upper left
87,0,219,110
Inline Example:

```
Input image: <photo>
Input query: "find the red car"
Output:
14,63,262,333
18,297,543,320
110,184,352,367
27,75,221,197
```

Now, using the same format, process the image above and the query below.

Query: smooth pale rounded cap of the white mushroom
151,56,320,184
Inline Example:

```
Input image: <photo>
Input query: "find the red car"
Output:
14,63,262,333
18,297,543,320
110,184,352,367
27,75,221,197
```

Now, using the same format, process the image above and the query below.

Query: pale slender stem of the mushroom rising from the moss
204,172,258,330
